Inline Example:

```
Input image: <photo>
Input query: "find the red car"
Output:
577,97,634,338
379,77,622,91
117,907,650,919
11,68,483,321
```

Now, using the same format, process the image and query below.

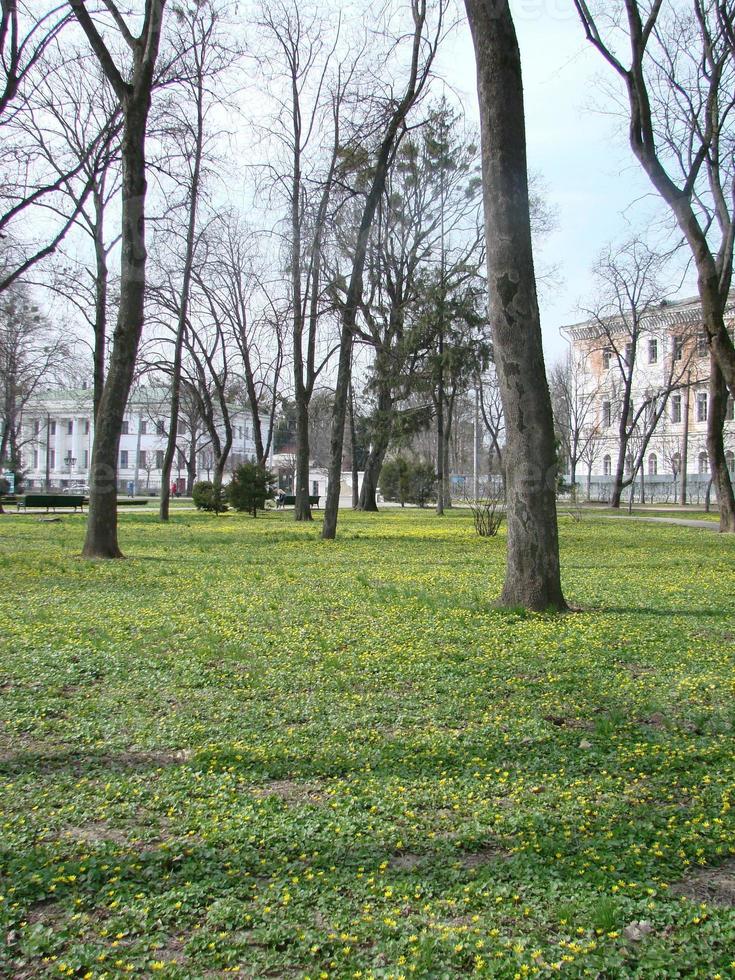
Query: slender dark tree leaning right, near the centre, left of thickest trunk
322,0,445,540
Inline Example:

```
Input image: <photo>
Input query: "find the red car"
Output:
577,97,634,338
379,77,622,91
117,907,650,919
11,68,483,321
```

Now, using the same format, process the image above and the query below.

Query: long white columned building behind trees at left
21,388,264,494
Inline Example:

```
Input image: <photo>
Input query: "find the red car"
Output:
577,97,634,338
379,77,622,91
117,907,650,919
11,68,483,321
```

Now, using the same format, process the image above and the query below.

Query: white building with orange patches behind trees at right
561,299,735,504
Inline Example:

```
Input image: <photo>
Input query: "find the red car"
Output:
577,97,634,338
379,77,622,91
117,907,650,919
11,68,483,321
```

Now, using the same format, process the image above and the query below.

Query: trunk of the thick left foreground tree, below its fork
82,107,150,558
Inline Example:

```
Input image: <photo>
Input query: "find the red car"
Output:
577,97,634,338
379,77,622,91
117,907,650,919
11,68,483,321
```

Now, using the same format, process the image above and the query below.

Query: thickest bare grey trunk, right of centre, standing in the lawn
465,0,566,610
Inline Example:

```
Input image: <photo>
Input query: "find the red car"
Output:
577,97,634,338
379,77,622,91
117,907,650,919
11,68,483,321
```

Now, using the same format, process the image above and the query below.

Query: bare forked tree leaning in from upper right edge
574,0,735,396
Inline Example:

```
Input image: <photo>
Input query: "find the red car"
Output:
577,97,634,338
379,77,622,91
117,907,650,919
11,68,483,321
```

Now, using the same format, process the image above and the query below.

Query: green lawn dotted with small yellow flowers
0,510,735,980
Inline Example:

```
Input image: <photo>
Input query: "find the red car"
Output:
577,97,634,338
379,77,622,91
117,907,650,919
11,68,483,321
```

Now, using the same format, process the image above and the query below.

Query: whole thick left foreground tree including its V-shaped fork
69,0,166,558
